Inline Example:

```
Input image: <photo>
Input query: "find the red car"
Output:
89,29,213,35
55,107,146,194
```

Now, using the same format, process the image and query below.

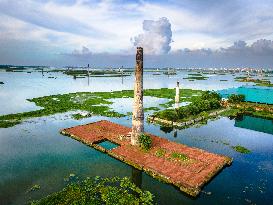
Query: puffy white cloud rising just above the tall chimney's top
132,17,172,55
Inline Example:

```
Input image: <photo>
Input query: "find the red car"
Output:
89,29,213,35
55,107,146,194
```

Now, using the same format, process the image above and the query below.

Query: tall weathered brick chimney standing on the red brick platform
131,47,144,145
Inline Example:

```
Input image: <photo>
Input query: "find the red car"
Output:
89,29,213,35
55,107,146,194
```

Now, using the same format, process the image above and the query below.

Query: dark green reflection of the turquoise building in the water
235,115,273,134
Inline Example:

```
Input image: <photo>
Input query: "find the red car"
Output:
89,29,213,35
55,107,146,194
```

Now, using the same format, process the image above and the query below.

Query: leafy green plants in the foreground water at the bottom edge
31,177,153,205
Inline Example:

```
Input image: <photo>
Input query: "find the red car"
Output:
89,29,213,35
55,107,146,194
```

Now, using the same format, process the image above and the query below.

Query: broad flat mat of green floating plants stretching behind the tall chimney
0,88,202,128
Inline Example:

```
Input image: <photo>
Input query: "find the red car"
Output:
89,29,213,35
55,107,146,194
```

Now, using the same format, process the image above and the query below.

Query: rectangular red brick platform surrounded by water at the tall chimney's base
61,121,232,196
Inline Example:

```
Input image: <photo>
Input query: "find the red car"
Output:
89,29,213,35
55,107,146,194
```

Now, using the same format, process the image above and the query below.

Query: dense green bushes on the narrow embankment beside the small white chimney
154,91,221,121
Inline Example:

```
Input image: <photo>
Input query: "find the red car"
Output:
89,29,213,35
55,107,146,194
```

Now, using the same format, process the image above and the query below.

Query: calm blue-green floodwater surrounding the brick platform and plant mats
0,69,273,205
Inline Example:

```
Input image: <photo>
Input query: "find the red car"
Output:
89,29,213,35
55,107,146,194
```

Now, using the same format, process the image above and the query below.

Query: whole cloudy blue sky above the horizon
0,0,273,67
